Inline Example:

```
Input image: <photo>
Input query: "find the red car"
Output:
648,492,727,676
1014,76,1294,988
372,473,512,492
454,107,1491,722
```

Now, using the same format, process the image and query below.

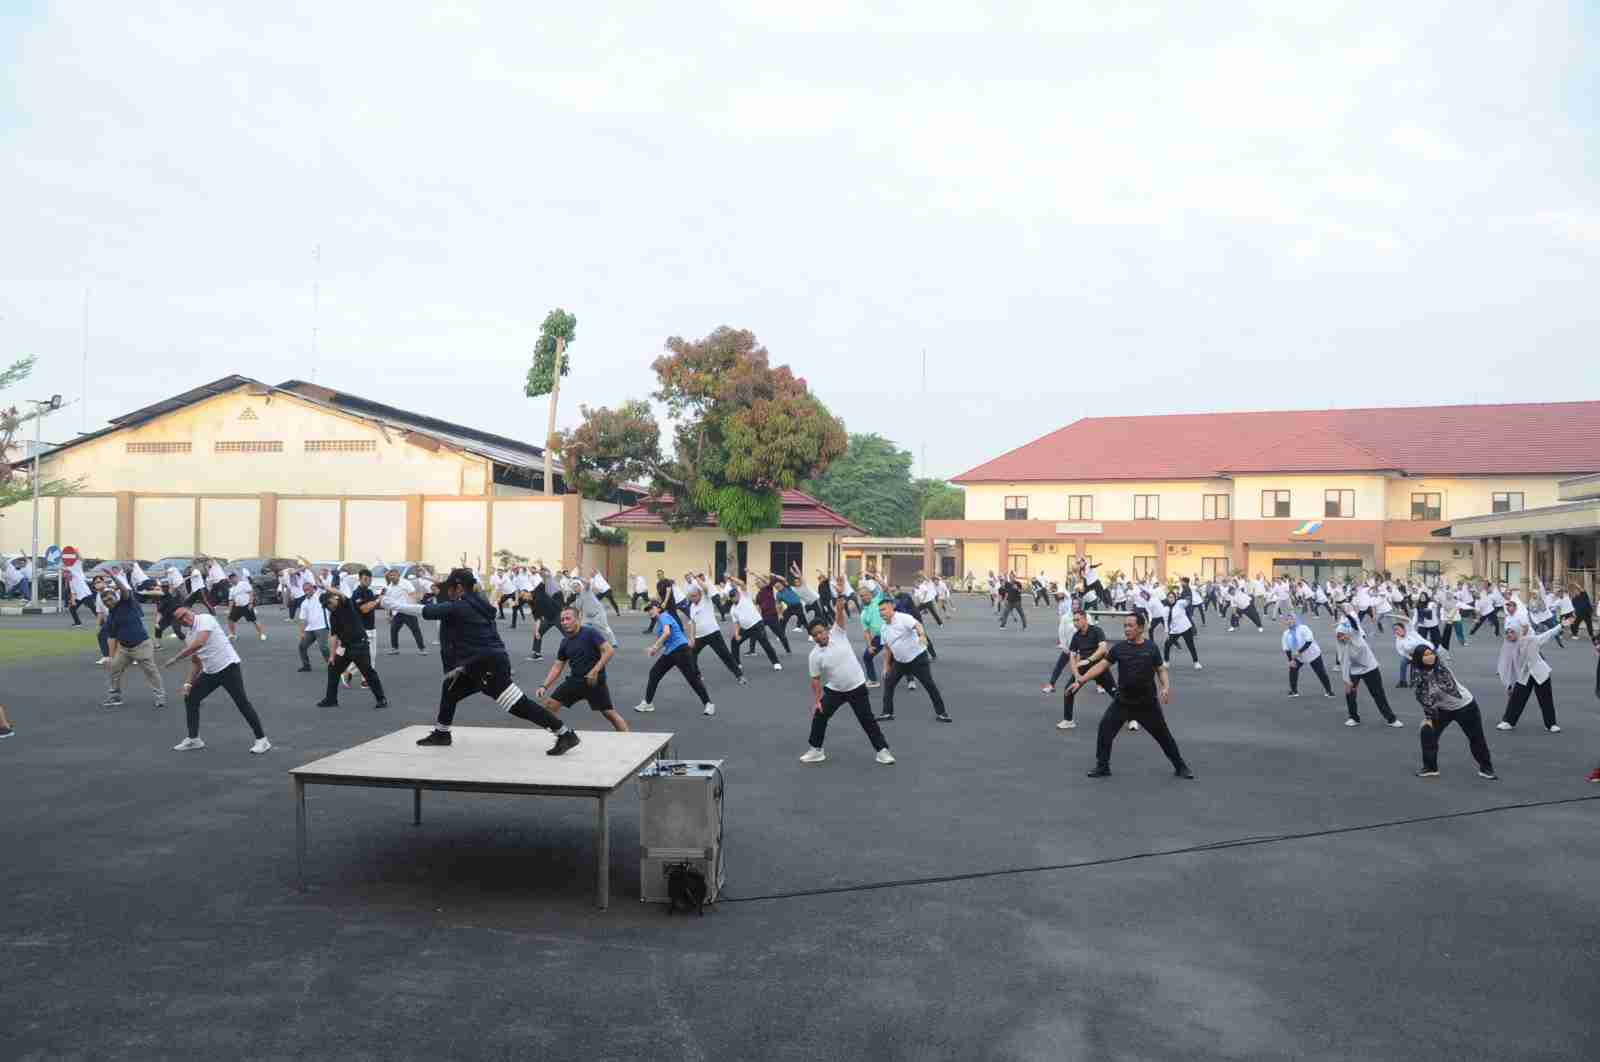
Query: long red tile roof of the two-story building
954,401,1600,483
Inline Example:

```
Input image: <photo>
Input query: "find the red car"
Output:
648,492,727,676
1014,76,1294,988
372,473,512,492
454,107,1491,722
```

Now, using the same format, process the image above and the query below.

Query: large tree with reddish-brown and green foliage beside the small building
558,326,846,541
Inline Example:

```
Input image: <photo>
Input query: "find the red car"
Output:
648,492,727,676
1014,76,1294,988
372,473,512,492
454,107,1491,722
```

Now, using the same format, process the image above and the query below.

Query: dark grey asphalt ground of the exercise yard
0,598,1600,1059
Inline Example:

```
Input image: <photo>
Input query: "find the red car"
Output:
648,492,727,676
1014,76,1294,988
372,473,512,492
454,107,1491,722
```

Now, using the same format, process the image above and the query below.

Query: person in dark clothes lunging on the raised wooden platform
397,568,579,757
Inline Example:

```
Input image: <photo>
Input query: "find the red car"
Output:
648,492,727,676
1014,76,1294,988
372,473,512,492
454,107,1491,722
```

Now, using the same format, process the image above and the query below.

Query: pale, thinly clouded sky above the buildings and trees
0,0,1600,477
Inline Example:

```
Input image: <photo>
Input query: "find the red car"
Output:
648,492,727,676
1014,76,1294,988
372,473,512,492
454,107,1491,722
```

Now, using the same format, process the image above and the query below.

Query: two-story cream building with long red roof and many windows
923,401,1600,584
